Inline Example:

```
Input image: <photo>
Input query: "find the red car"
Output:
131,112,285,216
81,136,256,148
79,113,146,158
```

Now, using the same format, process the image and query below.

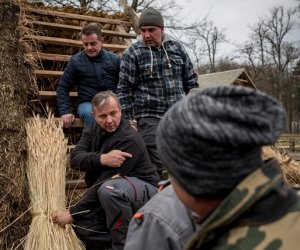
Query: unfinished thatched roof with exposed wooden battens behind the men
0,0,136,250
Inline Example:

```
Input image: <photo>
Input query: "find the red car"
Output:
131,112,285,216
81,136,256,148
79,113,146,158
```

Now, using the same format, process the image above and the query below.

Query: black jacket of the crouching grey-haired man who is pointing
70,120,159,187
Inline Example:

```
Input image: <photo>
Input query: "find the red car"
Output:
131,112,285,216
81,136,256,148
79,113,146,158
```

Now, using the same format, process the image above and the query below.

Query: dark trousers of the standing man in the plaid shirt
137,117,164,179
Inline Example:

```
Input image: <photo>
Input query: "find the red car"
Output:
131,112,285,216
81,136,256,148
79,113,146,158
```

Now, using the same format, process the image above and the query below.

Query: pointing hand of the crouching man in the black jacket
100,149,132,168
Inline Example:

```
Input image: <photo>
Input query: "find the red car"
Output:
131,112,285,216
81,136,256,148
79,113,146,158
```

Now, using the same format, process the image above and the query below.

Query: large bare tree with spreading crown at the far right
240,6,299,95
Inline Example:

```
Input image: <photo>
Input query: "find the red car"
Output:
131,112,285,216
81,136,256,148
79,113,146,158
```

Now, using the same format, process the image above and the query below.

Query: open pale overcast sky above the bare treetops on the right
177,0,300,56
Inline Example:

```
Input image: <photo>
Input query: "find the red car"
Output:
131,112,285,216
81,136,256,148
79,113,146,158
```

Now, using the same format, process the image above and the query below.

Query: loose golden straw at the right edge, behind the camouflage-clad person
263,146,300,185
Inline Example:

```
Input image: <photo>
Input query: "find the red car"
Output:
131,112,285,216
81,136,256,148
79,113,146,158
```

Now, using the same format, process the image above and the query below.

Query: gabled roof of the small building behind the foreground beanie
198,69,256,89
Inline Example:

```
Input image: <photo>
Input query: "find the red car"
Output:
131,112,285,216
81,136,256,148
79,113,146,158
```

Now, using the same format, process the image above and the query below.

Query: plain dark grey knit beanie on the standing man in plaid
139,7,164,28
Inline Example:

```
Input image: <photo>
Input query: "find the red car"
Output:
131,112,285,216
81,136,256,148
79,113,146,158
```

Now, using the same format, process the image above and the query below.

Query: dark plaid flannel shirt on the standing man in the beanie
118,36,198,120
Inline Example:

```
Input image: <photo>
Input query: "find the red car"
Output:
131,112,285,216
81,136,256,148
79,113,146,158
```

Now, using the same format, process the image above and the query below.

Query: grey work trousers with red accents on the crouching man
73,177,157,250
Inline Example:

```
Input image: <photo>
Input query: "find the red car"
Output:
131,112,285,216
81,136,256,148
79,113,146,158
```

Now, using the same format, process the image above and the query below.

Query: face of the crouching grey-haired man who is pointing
93,97,121,133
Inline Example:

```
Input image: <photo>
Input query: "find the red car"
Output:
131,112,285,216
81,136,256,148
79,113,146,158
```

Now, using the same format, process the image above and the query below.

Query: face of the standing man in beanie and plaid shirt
140,26,163,47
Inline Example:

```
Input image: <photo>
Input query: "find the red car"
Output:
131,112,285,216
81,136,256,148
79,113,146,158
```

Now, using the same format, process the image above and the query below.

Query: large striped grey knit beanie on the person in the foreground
157,86,286,198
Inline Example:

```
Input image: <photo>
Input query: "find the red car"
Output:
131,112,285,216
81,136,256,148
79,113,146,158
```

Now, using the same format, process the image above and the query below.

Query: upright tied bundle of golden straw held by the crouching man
25,115,84,250
